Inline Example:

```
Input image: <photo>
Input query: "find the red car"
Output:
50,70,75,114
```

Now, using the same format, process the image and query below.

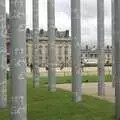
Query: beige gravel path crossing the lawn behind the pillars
57,83,115,103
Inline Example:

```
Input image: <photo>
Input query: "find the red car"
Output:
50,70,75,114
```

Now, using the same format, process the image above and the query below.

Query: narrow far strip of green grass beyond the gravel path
29,75,112,84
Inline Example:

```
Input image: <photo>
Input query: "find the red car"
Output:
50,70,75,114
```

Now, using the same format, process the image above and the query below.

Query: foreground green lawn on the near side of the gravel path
0,81,114,120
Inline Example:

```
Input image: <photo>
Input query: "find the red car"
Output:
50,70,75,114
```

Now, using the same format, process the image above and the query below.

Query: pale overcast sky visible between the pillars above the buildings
6,0,111,45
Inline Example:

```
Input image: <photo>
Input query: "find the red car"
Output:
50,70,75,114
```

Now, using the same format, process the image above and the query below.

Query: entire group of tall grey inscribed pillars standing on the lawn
0,0,120,120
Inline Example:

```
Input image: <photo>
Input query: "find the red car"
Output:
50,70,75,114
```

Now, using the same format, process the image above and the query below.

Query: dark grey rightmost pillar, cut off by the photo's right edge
114,0,120,120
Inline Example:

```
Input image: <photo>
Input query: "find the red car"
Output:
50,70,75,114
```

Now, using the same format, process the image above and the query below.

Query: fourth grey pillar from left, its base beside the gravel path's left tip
47,0,56,92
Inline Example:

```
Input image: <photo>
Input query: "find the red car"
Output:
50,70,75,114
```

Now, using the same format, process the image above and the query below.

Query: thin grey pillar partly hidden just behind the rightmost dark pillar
111,0,115,87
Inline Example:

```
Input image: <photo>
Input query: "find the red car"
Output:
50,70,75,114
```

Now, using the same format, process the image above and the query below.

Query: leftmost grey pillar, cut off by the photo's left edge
0,0,7,108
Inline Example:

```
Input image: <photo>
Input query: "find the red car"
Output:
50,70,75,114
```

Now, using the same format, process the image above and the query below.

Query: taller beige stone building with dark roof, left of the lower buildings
26,29,71,67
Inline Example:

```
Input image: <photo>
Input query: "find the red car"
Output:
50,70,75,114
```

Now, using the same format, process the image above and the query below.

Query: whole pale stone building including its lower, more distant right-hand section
26,29,112,67
